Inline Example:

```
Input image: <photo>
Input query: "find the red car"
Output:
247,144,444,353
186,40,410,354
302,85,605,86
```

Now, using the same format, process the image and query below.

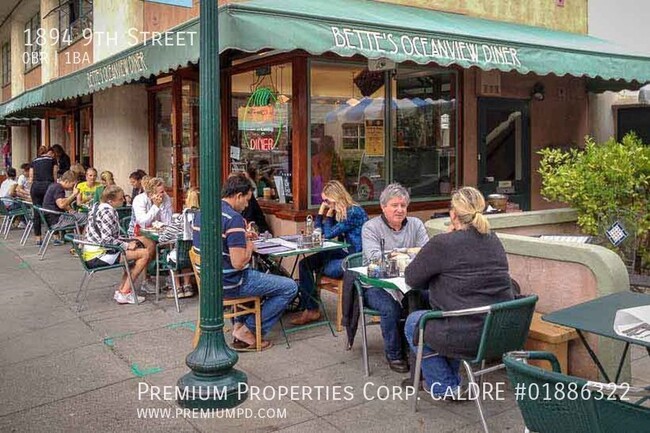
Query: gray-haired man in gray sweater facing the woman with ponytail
361,183,429,373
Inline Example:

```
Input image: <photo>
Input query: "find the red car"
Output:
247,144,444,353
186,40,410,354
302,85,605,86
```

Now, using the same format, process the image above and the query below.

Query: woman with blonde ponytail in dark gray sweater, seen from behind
405,187,513,397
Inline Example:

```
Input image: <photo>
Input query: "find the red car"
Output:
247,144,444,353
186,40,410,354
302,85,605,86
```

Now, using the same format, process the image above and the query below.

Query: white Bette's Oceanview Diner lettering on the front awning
330,26,521,67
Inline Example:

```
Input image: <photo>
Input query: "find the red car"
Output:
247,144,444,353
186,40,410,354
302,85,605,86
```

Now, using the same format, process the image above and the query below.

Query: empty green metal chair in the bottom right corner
503,352,650,433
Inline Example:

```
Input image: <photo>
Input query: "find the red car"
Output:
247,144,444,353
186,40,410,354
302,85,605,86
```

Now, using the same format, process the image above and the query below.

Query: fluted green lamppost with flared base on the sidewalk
177,0,248,409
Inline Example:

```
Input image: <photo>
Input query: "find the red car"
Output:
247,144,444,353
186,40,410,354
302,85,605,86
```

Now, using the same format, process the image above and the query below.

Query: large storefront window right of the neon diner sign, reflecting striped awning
309,61,457,206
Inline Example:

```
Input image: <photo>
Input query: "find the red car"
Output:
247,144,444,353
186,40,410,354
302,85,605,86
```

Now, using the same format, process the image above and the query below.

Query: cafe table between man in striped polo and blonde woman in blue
253,237,349,347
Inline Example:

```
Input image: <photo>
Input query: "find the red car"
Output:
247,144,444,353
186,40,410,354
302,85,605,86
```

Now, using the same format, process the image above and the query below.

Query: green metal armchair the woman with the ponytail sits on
412,295,538,433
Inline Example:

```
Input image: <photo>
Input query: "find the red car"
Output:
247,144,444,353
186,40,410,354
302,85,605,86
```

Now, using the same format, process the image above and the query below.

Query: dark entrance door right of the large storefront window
478,98,530,210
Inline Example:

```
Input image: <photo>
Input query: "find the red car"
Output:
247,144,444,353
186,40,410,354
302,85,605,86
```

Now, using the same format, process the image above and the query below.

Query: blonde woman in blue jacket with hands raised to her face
291,180,368,325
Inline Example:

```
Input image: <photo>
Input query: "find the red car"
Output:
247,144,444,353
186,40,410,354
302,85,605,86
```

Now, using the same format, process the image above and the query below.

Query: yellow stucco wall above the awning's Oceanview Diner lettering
377,0,584,33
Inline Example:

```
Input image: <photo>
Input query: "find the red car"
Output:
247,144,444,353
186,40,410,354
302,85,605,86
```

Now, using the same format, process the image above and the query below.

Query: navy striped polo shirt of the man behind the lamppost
192,200,249,290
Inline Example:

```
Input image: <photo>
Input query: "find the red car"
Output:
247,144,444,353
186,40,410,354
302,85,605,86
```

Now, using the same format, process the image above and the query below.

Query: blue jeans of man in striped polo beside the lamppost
224,269,298,336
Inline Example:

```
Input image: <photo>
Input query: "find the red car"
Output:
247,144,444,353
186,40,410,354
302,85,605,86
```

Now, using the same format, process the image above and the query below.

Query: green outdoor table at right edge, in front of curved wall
542,291,650,383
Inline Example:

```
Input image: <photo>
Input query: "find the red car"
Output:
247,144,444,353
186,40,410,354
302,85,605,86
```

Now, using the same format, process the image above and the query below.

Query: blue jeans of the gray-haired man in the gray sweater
363,287,404,361
